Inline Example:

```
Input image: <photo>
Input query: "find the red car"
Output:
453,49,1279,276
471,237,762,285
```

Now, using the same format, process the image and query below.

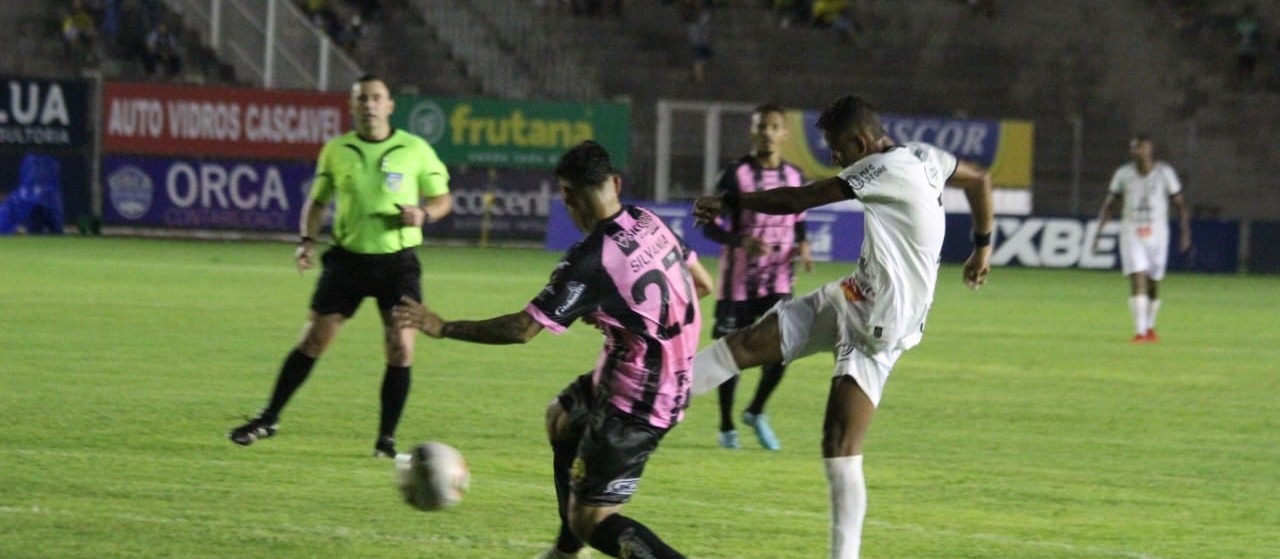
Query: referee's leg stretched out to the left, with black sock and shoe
228,311,346,446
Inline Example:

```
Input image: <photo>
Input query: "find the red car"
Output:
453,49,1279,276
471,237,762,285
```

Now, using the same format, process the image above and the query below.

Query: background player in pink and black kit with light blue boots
703,104,813,450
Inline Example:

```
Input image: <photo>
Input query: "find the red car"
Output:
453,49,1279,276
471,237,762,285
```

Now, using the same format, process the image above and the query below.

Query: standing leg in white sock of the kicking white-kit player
822,375,876,559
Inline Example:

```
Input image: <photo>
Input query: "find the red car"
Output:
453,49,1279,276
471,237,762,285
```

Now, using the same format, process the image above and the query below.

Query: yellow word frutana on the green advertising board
449,102,595,150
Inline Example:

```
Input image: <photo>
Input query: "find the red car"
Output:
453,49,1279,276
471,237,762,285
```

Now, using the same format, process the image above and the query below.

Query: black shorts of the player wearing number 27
558,374,668,507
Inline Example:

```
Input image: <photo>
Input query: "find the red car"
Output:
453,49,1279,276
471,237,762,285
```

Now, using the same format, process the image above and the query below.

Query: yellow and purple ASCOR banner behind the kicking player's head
782,110,1036,188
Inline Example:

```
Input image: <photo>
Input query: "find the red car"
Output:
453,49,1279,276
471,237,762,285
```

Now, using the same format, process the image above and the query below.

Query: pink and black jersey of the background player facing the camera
704,156,805,301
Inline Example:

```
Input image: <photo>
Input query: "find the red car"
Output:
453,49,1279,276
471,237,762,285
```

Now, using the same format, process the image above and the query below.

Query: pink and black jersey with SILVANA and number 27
525,206,701,429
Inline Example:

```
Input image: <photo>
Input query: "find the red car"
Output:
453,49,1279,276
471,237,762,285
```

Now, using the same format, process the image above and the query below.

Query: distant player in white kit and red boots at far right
1092,134,1192,344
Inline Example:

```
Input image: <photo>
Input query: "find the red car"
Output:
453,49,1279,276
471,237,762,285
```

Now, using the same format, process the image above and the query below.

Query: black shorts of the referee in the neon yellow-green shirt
311,247,422,319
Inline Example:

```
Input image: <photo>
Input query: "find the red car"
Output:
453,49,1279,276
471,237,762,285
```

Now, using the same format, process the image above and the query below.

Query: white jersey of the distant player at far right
1107,161,1183,243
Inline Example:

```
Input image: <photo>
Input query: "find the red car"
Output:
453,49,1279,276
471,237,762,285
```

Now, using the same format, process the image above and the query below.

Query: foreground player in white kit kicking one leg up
694,96,995,559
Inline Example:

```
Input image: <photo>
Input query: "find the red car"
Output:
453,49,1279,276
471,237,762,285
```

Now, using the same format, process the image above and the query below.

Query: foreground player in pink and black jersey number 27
396,141,712,559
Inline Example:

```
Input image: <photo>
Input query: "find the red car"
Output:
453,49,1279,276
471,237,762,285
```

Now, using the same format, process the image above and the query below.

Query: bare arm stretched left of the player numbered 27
392,297,543,345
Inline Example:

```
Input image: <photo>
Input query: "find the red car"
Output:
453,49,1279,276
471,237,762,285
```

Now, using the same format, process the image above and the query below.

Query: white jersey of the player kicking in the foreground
840,142,957,350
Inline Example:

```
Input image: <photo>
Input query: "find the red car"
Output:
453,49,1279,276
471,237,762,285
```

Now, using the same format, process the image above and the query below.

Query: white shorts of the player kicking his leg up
772,281,902,405
